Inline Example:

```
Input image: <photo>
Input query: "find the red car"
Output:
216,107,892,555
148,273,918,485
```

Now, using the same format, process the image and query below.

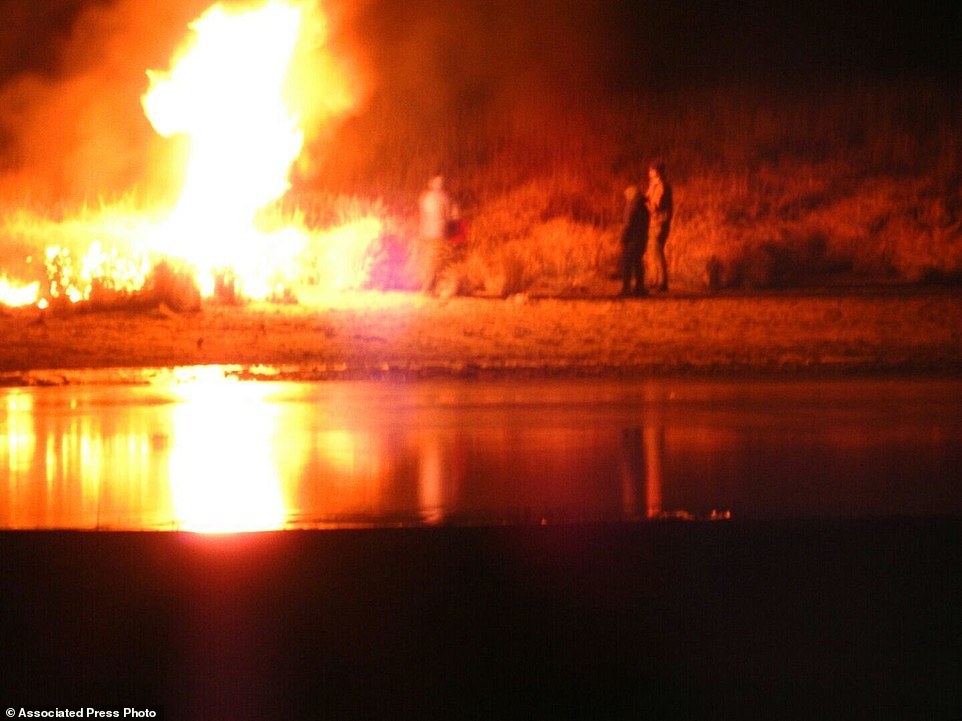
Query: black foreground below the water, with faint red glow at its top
0,518,962,719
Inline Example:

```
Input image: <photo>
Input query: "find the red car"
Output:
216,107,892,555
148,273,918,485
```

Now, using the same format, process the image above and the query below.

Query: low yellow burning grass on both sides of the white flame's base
0,199,399,311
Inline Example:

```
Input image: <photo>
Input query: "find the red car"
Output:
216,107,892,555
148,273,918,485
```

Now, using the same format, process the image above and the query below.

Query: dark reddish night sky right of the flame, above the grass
338,0,962,109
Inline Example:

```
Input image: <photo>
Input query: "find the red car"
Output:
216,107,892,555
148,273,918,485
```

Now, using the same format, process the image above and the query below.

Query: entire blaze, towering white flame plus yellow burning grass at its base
0,0,382,307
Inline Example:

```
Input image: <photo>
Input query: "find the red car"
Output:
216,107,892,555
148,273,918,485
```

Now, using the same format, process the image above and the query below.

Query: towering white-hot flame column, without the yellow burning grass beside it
143,0,306,297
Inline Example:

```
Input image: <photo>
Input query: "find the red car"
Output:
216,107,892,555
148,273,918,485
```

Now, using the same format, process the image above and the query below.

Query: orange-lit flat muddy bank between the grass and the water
0,287,962,385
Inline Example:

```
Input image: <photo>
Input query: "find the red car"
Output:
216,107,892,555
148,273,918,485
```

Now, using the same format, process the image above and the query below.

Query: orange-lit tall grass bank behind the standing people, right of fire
319,80,962,294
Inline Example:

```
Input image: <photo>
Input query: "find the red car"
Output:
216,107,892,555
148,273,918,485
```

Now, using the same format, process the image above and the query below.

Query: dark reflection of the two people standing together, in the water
621,422,664,518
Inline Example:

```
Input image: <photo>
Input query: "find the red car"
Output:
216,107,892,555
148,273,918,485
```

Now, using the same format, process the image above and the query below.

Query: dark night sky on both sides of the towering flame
0,0,962,88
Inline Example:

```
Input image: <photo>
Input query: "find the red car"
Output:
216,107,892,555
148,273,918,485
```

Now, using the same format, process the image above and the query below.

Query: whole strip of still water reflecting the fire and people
0,368,962,531
